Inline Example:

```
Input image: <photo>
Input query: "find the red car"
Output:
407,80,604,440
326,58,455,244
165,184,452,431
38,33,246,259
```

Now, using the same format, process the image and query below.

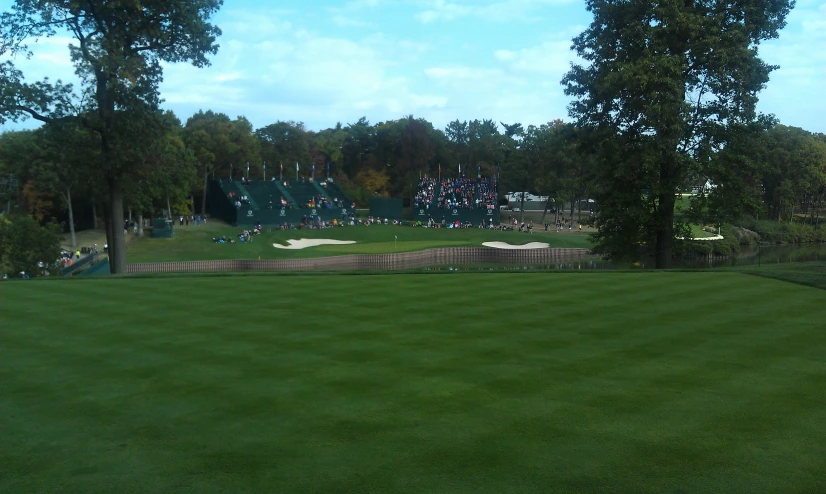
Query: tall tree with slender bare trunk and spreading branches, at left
0,0,222,274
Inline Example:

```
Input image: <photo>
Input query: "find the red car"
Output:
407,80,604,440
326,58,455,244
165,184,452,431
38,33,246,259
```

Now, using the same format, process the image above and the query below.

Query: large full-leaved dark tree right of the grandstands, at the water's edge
562,0,793,268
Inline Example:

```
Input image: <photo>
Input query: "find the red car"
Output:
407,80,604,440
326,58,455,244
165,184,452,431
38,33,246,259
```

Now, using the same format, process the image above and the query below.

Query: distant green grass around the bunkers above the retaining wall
127,222,591,262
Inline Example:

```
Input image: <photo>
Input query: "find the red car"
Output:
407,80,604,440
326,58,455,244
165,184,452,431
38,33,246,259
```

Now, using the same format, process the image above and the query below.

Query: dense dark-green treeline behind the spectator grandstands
0,111,826,239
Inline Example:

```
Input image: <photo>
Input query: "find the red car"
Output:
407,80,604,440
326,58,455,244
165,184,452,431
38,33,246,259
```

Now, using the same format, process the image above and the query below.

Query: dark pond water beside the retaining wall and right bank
425,244,826,272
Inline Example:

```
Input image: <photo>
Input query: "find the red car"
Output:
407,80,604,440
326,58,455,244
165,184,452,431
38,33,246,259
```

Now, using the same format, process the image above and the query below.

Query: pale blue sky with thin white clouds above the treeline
0,0,826,133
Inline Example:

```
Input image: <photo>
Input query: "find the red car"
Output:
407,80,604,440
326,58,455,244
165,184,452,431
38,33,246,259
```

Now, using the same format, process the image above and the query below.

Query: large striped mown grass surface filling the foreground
0,272,826,493
